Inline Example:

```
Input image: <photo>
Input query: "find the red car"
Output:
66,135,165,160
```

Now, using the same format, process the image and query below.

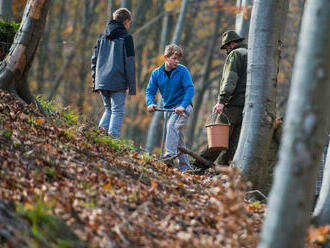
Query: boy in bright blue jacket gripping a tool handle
146,44,194,171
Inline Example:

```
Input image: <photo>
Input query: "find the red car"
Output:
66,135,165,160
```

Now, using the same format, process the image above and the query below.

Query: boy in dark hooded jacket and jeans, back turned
91,8,136,139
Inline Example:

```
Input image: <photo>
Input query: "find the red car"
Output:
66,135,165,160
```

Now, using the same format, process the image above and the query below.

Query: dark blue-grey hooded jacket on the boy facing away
91,20,136,95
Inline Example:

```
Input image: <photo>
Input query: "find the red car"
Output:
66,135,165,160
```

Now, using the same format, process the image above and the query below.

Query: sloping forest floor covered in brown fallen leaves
0,91,326,248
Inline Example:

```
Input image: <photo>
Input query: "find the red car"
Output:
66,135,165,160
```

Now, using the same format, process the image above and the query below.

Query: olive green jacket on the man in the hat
218,44,248,107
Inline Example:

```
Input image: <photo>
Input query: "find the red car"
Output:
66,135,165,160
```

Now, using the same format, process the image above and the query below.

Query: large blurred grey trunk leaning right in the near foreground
258,0,330,248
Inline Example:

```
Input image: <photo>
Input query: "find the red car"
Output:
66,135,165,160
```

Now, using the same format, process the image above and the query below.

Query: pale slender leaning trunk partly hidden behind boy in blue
146,0,189,152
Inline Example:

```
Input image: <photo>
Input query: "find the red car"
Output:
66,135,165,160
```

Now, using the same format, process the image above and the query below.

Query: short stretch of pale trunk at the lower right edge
313,138,330,226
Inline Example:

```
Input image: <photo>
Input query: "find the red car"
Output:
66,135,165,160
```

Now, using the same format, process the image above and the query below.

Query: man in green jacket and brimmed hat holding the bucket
194,30,248,169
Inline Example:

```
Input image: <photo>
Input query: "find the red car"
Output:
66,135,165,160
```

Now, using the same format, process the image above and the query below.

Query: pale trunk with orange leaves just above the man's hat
235,0,252,38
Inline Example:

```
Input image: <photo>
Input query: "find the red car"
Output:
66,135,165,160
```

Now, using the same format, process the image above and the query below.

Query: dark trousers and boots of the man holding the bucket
193,107,243,169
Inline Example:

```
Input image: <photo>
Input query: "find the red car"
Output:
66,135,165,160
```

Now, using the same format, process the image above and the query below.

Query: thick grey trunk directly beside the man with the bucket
233,0,288,193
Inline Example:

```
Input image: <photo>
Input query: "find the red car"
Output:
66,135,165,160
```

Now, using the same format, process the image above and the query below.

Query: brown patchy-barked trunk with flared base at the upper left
0,0,51,103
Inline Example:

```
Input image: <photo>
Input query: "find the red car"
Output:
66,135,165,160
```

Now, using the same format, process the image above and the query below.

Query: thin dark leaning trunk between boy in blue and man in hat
187,10,221,147
